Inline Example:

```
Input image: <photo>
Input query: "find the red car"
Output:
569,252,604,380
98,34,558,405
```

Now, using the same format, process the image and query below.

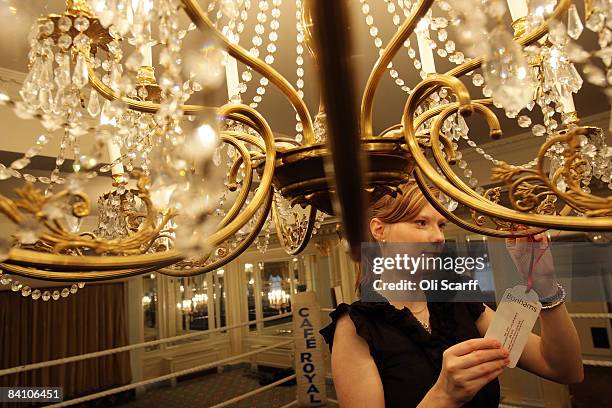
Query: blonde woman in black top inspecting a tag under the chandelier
321,182,583,408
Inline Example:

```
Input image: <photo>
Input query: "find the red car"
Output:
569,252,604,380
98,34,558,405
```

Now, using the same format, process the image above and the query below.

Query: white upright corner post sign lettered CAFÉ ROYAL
293,292,327,407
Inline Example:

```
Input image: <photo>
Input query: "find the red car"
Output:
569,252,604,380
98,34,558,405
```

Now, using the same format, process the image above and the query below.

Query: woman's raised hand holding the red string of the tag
506,234,557,298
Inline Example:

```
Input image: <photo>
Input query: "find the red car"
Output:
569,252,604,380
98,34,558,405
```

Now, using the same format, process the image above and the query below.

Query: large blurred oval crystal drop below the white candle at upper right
483,27,534,113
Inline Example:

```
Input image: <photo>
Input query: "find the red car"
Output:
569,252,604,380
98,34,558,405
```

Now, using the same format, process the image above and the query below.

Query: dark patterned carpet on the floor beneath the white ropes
117,367,337,408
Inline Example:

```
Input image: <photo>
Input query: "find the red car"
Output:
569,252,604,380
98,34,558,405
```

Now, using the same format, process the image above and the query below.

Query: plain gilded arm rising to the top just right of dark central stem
361,0,434,138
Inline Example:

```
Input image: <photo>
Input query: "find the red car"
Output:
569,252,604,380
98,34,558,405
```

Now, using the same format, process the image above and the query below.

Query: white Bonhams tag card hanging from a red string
485,285,542,368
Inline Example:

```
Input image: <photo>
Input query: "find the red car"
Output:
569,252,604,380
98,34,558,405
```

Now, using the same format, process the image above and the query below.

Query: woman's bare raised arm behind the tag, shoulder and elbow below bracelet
476,305,584,384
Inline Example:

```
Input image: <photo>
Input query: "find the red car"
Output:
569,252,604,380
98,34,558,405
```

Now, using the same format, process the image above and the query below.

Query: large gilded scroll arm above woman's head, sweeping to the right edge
402,75,612,231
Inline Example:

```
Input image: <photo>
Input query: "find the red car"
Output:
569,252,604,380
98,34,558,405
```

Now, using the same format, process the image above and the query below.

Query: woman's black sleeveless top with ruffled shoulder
320,297,499,408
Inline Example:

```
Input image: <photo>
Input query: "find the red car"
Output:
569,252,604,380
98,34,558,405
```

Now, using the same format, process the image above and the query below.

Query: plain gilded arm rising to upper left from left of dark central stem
181,0,315,144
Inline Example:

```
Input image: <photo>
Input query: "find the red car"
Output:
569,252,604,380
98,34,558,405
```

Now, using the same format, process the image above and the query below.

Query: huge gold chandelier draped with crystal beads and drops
0,0,612,299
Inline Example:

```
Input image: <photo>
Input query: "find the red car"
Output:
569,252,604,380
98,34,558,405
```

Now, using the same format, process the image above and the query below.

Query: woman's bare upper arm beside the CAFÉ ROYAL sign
332,314,384,408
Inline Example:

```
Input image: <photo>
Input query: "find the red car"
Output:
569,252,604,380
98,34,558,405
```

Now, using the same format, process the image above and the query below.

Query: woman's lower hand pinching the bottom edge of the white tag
429,338,510,407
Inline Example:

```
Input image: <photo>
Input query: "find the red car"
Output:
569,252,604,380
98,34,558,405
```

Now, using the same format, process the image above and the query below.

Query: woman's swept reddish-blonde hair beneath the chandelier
355,180,438,293
